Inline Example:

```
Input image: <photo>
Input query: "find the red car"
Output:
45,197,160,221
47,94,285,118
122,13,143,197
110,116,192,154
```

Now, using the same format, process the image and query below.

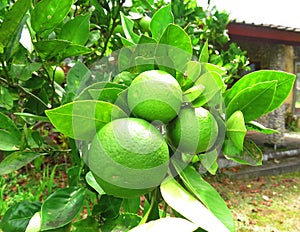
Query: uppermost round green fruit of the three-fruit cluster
128,70,182,123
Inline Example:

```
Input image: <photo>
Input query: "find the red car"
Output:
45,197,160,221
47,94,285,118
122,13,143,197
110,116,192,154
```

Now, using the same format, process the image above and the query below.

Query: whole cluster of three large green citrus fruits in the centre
88,70,218,197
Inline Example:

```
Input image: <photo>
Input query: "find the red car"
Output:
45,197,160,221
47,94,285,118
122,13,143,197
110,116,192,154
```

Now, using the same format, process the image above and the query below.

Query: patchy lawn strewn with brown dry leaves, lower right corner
206,172,300,232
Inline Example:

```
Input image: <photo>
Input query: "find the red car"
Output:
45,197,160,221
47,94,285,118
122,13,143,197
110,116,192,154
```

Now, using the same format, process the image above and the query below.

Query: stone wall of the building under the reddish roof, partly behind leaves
233,41,294,146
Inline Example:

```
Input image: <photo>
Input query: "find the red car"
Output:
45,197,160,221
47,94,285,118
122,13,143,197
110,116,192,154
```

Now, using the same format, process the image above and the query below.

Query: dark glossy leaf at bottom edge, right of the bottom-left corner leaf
41,187,85,230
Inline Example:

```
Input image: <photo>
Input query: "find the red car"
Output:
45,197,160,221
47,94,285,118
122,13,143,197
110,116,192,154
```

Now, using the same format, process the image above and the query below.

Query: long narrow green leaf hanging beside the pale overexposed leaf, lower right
175,166,234,231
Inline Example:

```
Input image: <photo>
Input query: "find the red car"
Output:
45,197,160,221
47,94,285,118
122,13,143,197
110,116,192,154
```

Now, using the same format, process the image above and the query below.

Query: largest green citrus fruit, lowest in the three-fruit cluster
88,118,169,197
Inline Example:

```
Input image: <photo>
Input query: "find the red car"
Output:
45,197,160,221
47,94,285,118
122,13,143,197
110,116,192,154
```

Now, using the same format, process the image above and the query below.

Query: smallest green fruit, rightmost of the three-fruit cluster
167,107,218,154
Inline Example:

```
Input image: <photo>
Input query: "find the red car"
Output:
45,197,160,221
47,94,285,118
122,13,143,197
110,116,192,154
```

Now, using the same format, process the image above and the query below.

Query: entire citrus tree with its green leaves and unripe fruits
0,0,295,232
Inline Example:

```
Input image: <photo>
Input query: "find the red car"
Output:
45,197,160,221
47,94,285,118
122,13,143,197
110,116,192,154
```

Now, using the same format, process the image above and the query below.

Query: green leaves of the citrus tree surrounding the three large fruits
0,0,295,231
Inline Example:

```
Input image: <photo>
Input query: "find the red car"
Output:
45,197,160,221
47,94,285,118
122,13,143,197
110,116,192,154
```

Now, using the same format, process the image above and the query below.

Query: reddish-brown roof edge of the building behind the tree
227,20,300,46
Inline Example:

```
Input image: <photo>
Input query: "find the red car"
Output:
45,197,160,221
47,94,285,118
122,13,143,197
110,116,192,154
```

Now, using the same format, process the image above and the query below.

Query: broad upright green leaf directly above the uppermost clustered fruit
155,24,193,71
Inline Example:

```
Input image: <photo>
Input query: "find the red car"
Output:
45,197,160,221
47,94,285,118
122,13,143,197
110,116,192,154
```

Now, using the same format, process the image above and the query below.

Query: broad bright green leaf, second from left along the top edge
31,0,73,34
